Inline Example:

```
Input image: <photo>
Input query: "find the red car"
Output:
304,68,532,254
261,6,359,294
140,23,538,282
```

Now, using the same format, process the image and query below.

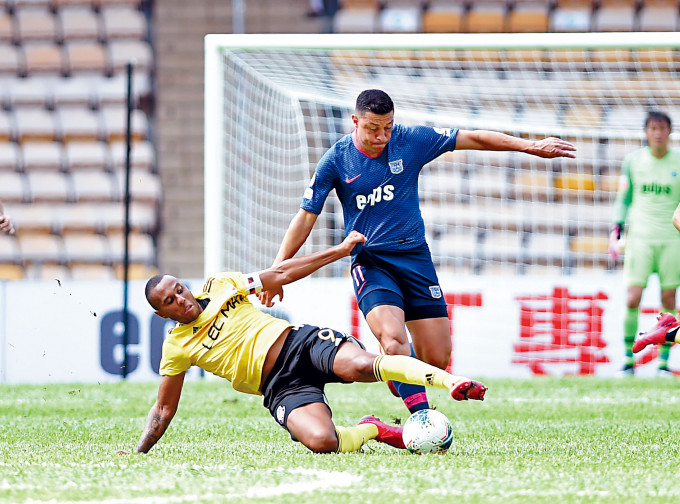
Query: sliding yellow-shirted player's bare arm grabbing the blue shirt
258,231,366,298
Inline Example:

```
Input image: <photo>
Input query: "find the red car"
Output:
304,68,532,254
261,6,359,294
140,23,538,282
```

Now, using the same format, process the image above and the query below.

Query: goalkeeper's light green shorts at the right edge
623,239,680,290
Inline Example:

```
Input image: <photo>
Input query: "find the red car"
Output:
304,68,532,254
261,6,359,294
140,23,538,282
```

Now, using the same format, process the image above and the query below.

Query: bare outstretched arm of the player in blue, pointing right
456,130,576,158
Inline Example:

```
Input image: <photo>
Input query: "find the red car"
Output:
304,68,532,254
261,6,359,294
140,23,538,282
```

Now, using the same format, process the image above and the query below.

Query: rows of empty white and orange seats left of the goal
0,0,156,280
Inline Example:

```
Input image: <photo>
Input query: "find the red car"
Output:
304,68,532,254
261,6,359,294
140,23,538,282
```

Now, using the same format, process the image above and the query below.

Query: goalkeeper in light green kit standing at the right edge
609,111,680,375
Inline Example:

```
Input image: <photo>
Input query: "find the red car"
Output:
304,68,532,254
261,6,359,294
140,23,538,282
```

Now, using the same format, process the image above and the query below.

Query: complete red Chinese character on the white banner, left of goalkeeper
512,287,609,375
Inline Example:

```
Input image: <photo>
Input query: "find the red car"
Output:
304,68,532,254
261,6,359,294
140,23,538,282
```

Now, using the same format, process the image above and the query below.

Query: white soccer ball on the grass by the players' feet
402,409,453,454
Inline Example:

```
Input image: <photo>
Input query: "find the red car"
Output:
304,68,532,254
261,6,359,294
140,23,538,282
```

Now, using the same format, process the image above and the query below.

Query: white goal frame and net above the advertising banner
204,32,680,276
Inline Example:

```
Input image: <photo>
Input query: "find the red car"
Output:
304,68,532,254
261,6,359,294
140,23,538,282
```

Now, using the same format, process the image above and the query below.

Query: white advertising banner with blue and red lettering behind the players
0,273,680,383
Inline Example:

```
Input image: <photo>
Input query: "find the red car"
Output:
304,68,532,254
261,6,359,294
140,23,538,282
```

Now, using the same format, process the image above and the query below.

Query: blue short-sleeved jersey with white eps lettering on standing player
300,124,458,250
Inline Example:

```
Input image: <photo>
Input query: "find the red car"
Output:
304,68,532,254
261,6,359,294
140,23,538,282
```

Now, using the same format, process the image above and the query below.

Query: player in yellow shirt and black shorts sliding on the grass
130,231,486,453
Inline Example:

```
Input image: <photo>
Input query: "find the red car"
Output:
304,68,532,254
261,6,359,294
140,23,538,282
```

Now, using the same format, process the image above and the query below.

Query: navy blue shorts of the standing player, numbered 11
352,243,448,322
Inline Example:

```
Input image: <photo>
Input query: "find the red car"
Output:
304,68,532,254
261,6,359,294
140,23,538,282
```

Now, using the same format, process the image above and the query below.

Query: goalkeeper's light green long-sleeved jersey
614,147,680,242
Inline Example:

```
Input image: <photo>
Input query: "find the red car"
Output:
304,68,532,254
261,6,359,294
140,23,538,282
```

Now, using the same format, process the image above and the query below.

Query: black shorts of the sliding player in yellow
262,325,364,429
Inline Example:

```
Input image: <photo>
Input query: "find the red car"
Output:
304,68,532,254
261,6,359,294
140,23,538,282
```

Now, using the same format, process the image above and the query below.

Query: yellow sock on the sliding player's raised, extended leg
373,355,460,390
